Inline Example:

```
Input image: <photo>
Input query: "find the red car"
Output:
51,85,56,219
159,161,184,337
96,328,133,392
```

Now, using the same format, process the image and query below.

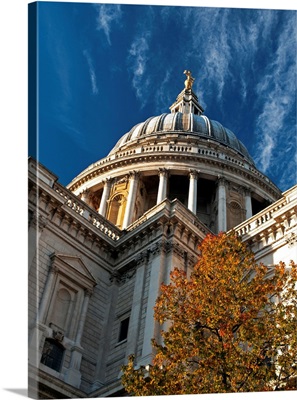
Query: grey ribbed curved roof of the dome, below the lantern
109,111,254,164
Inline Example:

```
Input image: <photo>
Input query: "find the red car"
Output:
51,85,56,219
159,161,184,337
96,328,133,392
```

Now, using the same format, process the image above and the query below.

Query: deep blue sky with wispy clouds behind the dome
29,2,297,191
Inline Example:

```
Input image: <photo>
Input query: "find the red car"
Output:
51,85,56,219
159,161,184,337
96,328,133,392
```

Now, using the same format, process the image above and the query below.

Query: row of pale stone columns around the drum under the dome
98,168,252,232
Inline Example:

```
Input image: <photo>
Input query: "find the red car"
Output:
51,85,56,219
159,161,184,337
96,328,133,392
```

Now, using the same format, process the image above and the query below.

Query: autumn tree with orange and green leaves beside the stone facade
122,233,297,396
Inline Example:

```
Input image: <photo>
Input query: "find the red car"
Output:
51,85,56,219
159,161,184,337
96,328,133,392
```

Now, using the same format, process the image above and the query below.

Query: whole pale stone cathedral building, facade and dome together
28,77,297,398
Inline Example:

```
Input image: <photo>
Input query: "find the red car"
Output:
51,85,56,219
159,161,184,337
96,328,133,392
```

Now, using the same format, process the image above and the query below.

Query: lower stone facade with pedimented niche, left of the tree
29,159,210,397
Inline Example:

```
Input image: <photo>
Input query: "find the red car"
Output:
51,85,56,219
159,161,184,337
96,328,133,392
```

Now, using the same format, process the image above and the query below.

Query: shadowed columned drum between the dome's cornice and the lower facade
72,160,273,232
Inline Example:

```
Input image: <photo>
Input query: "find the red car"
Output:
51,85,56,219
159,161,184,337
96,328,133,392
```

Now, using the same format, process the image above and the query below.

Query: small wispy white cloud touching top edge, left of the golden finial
94,4,122,45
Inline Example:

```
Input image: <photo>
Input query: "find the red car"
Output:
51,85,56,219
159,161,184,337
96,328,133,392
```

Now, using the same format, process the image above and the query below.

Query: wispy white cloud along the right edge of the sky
255,14,296,174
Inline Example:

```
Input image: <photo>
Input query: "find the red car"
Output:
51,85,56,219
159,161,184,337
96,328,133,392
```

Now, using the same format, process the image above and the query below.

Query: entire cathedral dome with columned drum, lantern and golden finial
68,71,279,233
